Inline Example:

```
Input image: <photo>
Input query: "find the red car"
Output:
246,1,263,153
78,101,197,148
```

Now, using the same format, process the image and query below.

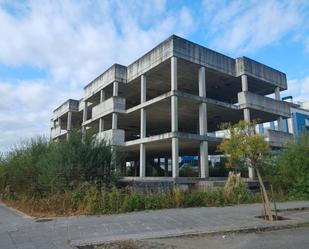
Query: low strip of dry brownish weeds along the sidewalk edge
0,184,260,216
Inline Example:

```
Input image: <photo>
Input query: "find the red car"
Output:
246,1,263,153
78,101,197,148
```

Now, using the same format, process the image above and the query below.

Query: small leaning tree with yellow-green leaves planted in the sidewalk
219,121,273,221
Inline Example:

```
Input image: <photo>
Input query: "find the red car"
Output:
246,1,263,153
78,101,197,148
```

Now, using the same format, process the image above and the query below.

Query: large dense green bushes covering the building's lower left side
0,131,116,198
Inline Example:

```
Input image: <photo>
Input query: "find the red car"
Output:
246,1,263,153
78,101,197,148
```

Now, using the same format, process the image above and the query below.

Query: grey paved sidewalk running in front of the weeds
0,201,309,249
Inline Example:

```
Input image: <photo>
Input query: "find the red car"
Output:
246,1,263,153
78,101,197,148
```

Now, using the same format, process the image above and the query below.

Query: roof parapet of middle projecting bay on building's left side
84,64,127,99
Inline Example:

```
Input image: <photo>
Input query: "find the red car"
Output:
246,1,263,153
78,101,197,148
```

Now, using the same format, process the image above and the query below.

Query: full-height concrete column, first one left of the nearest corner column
139,75,146,177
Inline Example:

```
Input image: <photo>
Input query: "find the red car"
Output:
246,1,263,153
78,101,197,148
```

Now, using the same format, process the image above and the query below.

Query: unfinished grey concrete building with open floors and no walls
51,35,291,178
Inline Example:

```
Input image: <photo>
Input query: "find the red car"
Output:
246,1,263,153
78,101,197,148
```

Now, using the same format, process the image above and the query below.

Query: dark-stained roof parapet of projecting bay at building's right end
236,57,287,90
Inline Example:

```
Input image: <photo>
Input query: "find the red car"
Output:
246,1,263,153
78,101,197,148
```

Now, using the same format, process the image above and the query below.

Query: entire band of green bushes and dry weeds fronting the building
0,127,309,216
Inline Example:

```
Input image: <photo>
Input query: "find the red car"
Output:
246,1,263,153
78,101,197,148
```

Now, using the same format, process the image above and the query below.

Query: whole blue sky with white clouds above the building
0,0,309,152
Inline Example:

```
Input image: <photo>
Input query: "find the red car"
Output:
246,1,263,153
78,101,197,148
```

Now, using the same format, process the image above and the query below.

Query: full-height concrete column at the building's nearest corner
171,57,179,178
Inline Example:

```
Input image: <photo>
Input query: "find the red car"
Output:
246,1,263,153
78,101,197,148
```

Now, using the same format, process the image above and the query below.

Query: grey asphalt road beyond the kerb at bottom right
146,227,309,249
